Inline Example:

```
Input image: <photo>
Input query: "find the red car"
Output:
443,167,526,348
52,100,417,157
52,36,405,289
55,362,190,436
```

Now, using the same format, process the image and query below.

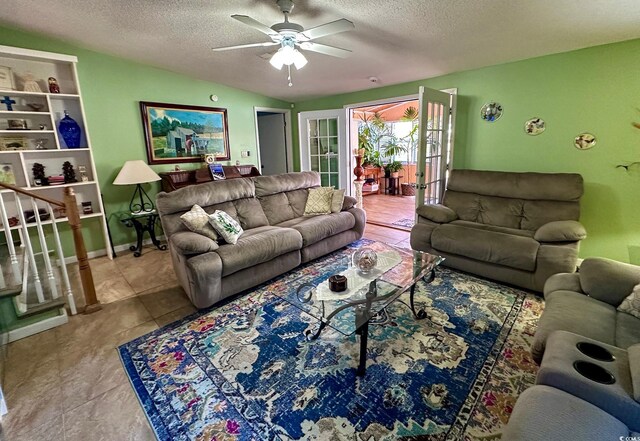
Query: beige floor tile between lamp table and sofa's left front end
115,250,177,293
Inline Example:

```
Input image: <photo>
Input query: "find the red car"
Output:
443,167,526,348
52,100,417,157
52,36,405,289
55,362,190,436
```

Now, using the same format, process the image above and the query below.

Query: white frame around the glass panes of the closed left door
298,109,353,191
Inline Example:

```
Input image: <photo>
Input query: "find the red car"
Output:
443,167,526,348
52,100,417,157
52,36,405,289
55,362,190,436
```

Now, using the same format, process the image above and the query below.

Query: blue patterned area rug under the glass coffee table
119,241,542,441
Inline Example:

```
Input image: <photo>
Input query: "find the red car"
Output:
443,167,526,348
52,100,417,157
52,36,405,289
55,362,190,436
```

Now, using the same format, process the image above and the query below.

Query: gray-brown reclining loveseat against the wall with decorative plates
411,170,586,292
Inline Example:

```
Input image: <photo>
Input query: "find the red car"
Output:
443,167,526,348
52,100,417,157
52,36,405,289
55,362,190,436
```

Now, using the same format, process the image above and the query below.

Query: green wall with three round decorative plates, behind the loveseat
295,40,640,264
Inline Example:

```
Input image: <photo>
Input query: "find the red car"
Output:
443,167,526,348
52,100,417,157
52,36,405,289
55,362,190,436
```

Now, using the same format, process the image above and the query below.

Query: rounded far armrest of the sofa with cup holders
580,257,640,307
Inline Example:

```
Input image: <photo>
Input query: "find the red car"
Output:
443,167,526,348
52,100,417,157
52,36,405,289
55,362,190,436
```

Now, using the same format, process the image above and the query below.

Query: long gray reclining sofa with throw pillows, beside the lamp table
156,172,366,308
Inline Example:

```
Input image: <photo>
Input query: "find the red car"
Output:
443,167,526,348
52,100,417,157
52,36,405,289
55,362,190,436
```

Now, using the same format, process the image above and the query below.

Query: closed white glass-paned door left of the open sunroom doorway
298,109,351,194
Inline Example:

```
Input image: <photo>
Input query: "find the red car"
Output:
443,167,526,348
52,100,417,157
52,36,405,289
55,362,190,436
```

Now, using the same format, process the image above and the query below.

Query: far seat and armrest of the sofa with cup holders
531,257,640,363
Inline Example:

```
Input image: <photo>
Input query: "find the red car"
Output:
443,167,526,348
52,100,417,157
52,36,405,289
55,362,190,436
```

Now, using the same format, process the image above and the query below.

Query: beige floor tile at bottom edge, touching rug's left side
64,384,155,441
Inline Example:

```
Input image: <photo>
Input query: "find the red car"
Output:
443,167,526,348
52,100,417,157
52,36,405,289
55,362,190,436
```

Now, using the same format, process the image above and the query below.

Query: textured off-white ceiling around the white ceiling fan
0,0,640,101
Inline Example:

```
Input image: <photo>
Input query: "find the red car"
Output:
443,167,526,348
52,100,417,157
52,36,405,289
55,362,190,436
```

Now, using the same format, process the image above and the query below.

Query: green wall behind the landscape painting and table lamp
0,26,289,253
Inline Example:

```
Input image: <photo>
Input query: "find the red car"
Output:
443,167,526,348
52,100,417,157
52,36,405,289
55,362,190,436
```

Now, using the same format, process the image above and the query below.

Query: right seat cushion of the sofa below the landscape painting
278,211,356,247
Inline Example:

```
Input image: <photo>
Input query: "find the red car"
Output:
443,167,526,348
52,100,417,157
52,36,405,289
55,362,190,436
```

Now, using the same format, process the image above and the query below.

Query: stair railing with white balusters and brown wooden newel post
0,182,102,314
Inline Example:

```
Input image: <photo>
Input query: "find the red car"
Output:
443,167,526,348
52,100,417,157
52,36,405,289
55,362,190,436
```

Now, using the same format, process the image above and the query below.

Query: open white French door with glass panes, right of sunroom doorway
416,87,455,208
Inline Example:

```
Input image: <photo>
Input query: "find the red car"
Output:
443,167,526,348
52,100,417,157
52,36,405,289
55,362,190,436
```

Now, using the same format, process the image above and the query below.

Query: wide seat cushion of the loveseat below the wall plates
431,224,539,271
